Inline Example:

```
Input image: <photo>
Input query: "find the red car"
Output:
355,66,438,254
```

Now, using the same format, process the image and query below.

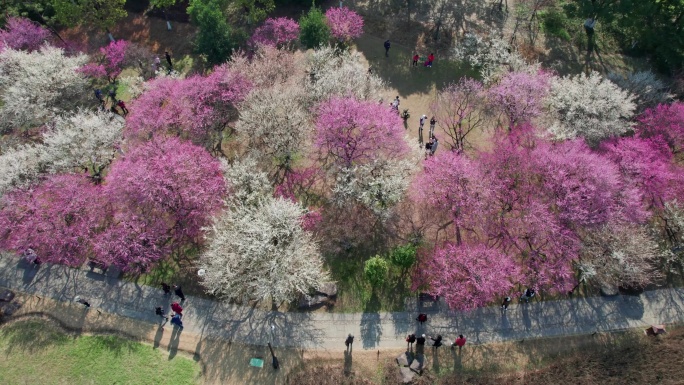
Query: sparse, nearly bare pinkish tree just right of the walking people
430,77,484,152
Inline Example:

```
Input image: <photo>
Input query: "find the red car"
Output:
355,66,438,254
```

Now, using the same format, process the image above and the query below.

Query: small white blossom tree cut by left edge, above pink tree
0,145,46,196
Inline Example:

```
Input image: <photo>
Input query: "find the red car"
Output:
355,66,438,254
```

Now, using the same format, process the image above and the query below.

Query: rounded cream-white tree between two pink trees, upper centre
235,87,313,171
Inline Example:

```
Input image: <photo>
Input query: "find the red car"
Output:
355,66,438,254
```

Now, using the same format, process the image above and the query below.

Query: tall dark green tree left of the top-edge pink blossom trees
188,0,245,65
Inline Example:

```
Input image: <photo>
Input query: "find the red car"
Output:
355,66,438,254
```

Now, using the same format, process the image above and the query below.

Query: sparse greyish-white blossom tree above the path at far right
577,224,658,286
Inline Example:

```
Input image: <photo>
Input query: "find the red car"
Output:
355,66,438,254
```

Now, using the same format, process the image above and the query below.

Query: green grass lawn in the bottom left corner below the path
0,320,200,385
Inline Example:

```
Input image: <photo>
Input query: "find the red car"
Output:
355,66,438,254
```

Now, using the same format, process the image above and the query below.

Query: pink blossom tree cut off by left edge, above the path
0,174,105,266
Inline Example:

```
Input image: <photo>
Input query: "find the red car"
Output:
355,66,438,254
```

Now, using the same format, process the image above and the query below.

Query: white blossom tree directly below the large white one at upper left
43,110,124,177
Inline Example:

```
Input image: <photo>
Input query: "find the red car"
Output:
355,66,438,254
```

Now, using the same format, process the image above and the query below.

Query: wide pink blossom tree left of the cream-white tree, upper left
125,65,252,151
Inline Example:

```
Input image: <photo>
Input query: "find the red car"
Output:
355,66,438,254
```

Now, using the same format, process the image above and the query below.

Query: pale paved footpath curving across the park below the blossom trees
0,254,684,350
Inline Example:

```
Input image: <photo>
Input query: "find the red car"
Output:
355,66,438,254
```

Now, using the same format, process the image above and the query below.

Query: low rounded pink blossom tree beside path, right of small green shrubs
413,243,519,310
